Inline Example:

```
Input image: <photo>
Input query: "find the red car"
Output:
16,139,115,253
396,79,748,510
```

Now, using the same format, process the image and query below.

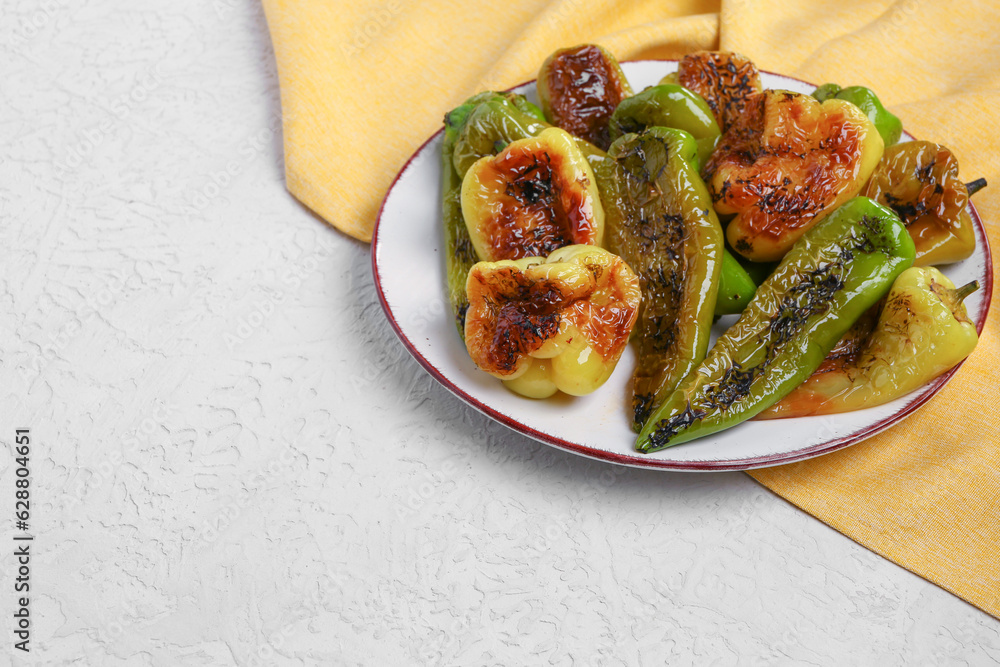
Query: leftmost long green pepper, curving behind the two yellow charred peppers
441,92,548,335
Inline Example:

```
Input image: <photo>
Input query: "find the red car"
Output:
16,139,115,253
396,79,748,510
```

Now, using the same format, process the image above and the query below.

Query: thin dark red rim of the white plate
371,60,993,472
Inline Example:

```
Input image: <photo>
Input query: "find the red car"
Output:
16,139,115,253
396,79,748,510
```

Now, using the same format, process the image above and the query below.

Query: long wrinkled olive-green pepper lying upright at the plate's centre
604,127,723,430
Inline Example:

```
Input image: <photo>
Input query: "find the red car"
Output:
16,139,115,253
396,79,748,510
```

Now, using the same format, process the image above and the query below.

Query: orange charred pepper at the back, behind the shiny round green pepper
660,51,762,132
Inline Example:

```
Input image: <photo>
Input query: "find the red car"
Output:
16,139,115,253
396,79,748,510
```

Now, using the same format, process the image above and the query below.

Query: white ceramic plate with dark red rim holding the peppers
372,60,993,470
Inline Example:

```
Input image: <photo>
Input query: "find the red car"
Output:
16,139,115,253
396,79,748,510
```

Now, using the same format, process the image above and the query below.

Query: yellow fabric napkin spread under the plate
264,0,1000,617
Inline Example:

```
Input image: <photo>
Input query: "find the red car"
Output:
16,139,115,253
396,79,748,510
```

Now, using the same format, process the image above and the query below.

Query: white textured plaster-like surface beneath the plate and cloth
0,0,1000,665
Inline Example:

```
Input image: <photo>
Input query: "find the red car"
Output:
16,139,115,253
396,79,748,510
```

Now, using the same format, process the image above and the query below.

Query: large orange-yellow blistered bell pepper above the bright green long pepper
704,90,882,262
